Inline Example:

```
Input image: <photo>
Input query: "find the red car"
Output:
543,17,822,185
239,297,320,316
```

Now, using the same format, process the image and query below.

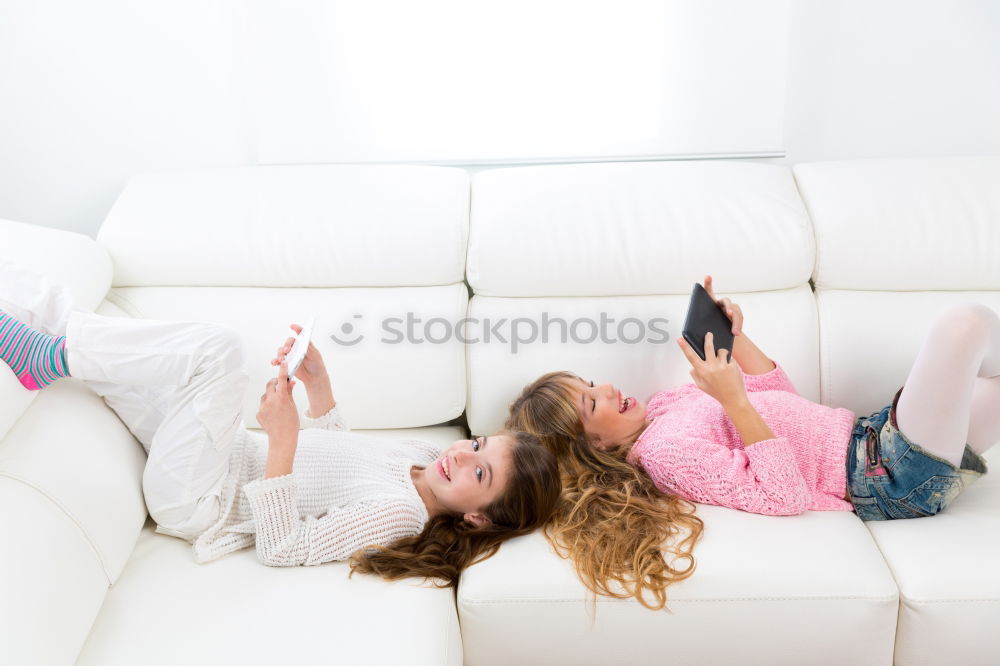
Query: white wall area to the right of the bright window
784,0,1000,164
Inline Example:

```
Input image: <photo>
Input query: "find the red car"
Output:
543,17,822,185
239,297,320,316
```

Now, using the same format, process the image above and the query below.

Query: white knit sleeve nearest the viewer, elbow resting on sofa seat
243,473,424,567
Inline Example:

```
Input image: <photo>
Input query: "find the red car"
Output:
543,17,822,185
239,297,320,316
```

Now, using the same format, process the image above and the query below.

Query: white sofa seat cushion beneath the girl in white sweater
76,426,463,666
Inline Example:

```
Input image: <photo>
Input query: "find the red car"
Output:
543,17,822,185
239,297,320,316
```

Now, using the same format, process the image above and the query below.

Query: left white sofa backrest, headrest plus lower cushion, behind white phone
98,166,469,428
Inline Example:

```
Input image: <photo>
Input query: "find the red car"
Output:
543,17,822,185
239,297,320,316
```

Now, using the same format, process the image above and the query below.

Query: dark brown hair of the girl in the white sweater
350,430,560,587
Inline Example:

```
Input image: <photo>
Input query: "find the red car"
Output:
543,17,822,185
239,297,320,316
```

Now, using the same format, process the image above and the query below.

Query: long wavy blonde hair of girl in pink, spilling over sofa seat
507,372,704,610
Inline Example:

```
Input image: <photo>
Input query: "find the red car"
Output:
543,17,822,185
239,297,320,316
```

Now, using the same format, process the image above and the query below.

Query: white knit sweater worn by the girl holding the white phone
194,407,439,566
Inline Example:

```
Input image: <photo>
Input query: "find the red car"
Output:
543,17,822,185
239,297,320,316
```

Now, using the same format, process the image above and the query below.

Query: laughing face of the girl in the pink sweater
567,377,647,451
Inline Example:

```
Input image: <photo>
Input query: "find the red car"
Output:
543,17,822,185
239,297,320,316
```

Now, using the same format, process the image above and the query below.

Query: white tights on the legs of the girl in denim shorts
896,304,1000,467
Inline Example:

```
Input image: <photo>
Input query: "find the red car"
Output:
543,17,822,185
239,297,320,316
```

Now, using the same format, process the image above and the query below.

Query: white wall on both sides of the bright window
0,0,1000,235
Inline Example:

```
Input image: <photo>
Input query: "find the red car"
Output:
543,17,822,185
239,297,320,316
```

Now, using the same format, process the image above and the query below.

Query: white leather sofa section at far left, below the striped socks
0,379,146,664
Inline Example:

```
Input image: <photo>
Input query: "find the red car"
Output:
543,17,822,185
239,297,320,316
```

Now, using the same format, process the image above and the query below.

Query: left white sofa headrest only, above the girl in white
98,165,469,288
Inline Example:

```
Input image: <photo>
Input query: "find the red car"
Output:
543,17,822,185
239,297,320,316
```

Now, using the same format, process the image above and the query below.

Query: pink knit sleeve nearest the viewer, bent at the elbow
640,437,812,516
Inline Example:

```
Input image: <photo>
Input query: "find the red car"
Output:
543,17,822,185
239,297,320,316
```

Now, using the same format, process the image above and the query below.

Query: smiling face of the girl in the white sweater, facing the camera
421,435,516,525
